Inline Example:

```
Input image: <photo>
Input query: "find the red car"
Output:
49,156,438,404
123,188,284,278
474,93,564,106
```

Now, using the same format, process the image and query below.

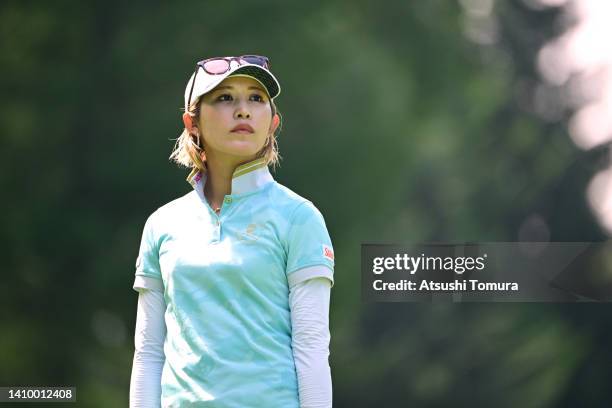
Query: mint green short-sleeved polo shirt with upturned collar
136,159,334,408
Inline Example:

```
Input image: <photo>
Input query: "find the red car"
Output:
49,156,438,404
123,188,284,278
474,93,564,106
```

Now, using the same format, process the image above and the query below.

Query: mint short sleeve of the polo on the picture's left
133,213,163,291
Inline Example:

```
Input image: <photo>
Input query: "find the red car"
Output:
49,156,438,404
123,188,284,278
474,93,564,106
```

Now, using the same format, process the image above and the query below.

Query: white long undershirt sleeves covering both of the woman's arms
130,266,332,408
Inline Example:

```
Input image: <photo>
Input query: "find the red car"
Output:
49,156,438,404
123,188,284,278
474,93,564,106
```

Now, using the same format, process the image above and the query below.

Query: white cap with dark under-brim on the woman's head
184,61,281,112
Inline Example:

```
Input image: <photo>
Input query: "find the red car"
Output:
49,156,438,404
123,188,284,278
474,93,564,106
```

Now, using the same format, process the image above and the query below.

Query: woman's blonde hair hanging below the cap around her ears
170,95,282,174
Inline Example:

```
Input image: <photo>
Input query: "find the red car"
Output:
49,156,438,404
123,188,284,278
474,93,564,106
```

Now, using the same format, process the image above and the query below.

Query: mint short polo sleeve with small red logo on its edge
286,201,334,286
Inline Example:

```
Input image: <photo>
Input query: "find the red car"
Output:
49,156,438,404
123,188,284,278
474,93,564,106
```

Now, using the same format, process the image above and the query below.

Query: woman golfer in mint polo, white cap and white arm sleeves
130,55,334,408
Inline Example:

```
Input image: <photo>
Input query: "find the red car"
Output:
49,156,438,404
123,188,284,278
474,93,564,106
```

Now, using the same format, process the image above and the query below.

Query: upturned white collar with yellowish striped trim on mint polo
187,158,274,195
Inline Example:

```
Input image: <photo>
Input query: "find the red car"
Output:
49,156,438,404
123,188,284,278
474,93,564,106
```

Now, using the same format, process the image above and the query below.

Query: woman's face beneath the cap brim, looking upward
198,77,275,161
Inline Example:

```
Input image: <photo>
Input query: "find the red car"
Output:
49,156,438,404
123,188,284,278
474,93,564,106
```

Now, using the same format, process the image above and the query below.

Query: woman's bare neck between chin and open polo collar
204,155,250,210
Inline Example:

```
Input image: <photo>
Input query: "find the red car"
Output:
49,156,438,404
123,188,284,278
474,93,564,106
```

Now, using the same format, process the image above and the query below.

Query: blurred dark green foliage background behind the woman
0,0,612,407
